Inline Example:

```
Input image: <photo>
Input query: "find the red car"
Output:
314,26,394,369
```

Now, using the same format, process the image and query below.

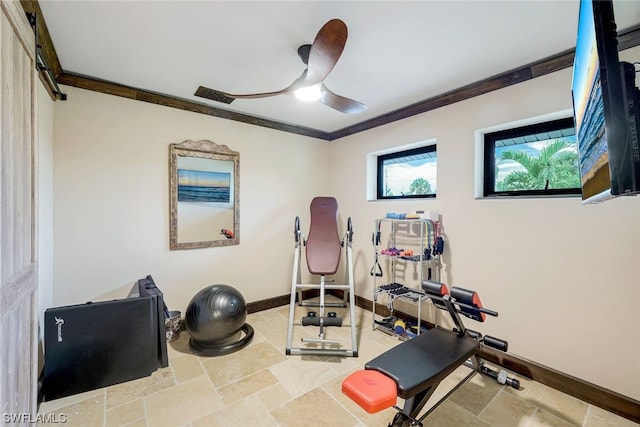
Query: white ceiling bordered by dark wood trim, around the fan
40,0,640,132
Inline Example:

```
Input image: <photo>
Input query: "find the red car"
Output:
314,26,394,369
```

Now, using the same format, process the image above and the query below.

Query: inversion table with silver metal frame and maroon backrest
285,197,358,357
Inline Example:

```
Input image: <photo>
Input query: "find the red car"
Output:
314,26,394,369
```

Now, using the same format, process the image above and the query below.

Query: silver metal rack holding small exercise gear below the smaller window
372,218,441,338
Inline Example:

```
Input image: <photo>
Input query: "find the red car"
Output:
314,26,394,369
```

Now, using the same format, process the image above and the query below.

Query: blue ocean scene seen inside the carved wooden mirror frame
178,169,231,203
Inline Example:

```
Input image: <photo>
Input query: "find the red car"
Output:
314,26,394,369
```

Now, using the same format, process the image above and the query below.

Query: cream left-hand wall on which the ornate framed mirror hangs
54,87,331,313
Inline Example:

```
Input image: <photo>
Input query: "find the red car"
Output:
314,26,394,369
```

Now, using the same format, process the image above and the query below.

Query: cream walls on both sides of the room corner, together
54,54,640,399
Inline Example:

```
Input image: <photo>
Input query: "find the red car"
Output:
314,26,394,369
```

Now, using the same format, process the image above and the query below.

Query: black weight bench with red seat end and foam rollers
342,280,520,427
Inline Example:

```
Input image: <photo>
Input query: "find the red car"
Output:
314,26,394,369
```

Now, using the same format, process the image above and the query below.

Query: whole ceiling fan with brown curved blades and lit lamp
194,19,367,114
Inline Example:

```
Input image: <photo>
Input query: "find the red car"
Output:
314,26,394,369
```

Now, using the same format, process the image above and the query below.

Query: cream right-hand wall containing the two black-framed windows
331,64,640,399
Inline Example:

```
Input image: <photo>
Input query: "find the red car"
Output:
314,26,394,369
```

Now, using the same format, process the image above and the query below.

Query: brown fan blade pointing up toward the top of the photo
305,19,348,86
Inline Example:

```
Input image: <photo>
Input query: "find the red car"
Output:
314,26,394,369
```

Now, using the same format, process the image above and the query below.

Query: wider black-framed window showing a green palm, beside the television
484,117,580,197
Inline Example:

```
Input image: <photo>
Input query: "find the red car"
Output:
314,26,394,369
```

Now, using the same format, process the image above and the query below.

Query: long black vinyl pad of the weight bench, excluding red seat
365,328,480,399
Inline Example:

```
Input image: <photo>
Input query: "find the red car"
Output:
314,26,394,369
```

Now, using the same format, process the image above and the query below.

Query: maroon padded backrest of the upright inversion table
305,197,342,275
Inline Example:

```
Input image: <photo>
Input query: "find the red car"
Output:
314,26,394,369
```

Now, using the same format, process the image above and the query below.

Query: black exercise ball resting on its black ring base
184,285,253,356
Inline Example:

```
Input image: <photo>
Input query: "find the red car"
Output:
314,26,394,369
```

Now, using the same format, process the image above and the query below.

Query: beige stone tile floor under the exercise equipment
40,300,637,427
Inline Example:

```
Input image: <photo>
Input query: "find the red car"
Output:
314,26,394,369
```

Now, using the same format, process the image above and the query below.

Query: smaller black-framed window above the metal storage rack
377,144,438,199
